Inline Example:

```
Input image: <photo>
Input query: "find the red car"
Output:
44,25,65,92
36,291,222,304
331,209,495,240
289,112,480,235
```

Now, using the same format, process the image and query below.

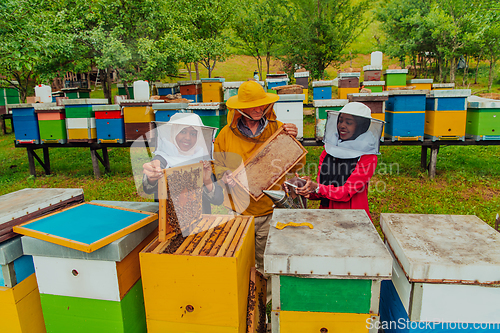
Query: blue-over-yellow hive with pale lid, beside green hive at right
424,89,471,141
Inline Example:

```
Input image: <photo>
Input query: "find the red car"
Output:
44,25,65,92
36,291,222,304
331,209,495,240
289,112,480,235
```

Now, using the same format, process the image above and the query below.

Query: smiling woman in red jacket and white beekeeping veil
297,102,383,219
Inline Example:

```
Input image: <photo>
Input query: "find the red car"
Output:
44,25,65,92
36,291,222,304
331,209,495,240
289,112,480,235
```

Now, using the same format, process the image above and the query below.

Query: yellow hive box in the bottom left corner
0,274,45,333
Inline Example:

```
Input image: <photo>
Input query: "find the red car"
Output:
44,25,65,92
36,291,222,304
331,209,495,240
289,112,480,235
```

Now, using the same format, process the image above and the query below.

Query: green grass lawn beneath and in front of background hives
0,110,500,232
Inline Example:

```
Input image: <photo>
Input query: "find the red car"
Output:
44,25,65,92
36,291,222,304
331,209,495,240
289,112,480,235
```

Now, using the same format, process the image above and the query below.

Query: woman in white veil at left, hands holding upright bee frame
142,113,224,214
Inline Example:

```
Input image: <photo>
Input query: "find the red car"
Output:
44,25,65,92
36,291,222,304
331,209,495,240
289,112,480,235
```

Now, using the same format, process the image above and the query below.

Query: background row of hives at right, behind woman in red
314,89,500,141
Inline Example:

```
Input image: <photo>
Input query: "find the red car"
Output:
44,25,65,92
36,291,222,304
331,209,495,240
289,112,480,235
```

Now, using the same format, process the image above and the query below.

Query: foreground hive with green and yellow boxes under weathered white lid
264,209,392,333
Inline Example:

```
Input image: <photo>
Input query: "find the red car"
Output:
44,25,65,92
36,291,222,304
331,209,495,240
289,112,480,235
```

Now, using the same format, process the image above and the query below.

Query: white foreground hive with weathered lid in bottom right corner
380,213,500,333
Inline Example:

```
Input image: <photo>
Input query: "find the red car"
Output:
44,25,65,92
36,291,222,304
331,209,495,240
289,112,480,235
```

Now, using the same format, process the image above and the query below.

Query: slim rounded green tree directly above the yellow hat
233,0,287,80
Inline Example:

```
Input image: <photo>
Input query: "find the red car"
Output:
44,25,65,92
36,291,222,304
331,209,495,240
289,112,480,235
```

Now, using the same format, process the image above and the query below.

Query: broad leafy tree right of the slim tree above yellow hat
283,0,369,79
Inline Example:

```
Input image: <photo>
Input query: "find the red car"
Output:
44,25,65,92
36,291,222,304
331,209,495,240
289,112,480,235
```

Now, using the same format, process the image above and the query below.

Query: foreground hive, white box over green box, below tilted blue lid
22,201,158,333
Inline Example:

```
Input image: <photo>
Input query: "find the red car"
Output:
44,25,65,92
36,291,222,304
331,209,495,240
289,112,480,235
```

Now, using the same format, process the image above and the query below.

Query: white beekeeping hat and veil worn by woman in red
323,102,384,159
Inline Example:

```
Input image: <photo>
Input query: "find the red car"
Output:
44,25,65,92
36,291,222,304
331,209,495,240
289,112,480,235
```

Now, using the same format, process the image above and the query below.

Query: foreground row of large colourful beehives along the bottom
0,189,500,333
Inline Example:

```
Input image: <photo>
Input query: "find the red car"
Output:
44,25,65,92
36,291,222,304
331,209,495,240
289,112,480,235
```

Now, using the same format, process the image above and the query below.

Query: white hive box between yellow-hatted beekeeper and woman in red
274,94,305,140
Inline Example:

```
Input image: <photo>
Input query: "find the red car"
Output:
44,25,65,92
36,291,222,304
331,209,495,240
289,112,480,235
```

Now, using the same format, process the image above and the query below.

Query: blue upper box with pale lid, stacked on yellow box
425,89,471,111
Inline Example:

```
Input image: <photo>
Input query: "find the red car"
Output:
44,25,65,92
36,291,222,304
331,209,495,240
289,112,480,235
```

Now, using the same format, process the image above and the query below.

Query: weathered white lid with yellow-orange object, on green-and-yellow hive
264,209,392,279
